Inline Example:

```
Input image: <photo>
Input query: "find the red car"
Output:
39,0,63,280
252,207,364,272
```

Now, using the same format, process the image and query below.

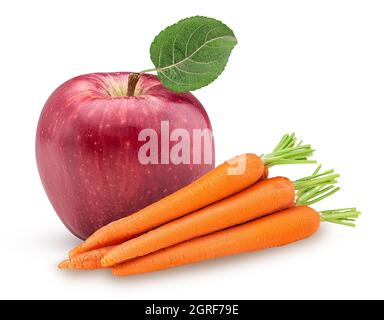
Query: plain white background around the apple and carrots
0,0,384,299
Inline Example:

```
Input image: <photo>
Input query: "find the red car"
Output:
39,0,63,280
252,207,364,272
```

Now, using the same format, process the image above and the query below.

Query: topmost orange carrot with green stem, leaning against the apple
69,134,315,257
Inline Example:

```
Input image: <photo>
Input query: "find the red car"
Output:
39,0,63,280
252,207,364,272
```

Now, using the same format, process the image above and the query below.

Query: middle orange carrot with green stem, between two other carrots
101,165,338,267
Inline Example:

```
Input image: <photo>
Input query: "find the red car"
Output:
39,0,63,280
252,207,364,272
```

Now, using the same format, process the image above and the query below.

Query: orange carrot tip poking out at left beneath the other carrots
59,246,114,270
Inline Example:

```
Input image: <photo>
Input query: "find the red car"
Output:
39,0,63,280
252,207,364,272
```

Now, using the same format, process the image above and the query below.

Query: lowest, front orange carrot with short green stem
112,206,359,276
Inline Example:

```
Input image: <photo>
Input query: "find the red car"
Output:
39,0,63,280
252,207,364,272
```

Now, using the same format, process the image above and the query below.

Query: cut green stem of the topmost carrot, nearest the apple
262,133,316,167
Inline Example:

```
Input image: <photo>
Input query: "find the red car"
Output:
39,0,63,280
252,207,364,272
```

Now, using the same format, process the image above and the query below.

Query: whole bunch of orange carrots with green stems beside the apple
59,134,360,275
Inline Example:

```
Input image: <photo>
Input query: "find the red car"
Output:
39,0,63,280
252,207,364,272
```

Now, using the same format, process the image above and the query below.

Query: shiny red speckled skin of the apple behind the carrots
36,72,214,239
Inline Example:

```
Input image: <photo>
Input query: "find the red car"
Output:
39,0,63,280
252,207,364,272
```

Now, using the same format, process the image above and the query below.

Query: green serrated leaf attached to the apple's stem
151,16,237,92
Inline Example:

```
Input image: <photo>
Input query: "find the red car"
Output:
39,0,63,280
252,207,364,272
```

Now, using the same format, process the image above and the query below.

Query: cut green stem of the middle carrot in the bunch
293,165,340,206
